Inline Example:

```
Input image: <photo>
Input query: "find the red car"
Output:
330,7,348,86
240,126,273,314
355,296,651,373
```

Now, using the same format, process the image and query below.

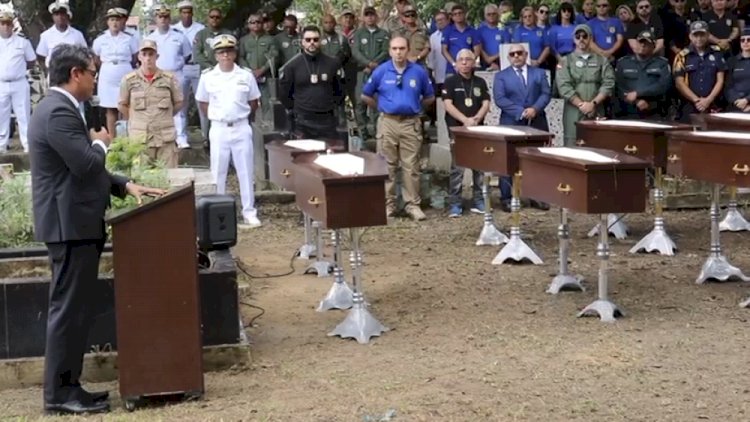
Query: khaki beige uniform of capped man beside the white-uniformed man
119,69,183,168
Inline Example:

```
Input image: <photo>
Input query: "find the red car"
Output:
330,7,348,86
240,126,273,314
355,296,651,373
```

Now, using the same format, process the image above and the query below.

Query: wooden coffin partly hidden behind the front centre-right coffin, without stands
576,120,692,171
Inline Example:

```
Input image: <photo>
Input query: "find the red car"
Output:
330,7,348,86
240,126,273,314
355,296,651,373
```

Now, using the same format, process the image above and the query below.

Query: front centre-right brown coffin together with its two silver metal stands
518,148,649,321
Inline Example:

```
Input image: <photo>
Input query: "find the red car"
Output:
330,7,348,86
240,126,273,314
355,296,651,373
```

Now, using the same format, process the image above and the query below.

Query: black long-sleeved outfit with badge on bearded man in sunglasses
278,41,342,139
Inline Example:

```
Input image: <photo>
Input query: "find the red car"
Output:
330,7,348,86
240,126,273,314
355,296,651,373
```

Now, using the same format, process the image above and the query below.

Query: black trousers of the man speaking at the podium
44,239,104,403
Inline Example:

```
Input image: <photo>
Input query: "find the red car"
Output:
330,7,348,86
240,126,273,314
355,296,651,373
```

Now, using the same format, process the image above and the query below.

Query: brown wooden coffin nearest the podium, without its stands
294,151,388,229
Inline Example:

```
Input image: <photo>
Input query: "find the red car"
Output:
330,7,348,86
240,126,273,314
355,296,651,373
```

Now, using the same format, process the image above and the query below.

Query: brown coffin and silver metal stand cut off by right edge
670,132,750,284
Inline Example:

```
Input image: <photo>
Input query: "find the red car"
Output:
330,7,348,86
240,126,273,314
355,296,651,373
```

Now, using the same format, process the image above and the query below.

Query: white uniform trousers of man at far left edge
0,75,31,152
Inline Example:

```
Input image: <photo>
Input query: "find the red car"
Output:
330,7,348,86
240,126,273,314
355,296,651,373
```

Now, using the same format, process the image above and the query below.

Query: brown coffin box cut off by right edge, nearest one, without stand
669,131,750,187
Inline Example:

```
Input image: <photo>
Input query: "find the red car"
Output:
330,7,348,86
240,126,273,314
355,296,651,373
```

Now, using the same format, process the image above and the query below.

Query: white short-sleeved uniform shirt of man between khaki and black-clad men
195,65,260,123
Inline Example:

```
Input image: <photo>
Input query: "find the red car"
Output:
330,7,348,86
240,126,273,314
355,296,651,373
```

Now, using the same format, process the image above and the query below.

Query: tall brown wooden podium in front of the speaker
108,184,204,410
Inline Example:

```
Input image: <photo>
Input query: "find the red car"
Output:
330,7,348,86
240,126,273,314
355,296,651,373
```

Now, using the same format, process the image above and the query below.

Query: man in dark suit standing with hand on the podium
29,44,164,413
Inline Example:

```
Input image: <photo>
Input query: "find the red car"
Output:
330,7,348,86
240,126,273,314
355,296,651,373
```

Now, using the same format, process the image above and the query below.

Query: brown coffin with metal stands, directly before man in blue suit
450,126,554,264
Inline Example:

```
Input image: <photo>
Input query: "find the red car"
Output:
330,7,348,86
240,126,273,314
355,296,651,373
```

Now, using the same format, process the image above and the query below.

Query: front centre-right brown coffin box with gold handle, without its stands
518,148,651,214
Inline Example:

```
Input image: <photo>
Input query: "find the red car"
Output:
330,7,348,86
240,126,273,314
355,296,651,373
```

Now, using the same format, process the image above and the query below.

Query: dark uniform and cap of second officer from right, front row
672,21,727,122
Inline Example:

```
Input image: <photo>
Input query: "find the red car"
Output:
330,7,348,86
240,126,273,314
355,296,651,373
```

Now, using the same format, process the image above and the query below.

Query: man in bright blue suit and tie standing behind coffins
492,44,550,211
